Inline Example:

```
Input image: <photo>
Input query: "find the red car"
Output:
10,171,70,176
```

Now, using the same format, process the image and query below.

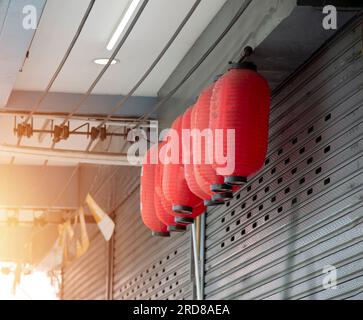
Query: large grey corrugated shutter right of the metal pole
205,15,363,299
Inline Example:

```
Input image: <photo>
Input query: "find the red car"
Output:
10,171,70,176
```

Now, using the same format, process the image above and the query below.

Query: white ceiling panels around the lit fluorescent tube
15,0,226,96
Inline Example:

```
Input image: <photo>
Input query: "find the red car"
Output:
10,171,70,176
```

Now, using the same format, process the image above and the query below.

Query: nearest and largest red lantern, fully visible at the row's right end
209,62,270,185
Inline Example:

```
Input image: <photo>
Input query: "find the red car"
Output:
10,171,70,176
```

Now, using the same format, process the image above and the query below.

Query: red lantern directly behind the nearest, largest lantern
191,84,233,206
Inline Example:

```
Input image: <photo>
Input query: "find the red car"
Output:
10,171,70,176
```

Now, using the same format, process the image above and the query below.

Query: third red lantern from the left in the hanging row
161,116,203,224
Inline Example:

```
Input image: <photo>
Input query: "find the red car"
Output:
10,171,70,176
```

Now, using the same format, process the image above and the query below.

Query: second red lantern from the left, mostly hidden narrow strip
153,142,186,232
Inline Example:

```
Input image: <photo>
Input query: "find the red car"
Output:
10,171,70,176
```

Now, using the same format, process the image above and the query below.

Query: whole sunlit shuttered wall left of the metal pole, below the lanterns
63,167,193,300
